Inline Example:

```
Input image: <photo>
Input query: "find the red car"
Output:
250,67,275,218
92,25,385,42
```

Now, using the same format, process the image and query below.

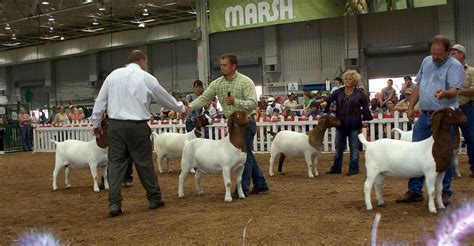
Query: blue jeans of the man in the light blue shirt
408,113,454,196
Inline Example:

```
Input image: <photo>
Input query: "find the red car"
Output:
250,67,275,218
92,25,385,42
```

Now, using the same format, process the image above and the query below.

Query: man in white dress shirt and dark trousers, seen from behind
92,50,185,217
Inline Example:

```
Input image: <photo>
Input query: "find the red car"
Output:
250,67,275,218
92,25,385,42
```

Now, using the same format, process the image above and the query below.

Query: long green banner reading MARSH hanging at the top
209,0,447,32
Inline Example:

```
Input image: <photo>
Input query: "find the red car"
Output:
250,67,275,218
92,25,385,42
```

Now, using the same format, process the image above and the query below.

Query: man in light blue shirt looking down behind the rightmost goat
397,35,465,206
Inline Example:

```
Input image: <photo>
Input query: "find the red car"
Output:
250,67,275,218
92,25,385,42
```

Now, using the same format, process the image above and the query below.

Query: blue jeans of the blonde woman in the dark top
331,128,359,173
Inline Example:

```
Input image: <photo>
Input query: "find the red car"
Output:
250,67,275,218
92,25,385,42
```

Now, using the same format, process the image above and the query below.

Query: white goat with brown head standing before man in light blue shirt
358,108,467,213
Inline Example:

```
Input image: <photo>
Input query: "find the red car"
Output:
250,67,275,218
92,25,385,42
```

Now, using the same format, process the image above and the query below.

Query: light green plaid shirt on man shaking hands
189,71,257,117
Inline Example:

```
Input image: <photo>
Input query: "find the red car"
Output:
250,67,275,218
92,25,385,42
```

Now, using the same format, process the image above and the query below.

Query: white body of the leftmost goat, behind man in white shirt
51,139,109,192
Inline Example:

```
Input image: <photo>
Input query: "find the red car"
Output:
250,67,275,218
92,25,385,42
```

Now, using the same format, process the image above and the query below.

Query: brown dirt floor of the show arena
0,153,474,245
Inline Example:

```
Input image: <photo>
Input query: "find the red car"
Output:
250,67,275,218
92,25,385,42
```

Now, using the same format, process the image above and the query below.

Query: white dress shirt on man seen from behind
92,63,185,128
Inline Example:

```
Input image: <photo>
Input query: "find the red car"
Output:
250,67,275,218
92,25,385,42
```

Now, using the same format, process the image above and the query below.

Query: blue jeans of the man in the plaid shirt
242,120,268,196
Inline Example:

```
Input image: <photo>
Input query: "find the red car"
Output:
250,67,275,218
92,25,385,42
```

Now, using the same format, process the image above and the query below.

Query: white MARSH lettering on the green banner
225,0,295,28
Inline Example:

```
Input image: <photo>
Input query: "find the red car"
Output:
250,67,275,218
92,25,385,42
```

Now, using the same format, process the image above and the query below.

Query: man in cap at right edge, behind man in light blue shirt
451,44,474,178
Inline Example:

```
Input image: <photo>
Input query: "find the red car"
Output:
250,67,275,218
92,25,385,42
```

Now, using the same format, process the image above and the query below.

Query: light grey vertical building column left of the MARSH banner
196,0,211,87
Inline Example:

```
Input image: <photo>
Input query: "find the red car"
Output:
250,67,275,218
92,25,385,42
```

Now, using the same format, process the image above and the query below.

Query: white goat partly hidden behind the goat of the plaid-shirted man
153,114,213,173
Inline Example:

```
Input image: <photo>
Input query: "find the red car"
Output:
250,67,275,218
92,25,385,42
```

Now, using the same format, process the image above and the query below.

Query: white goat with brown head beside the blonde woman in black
269,115,341,178
